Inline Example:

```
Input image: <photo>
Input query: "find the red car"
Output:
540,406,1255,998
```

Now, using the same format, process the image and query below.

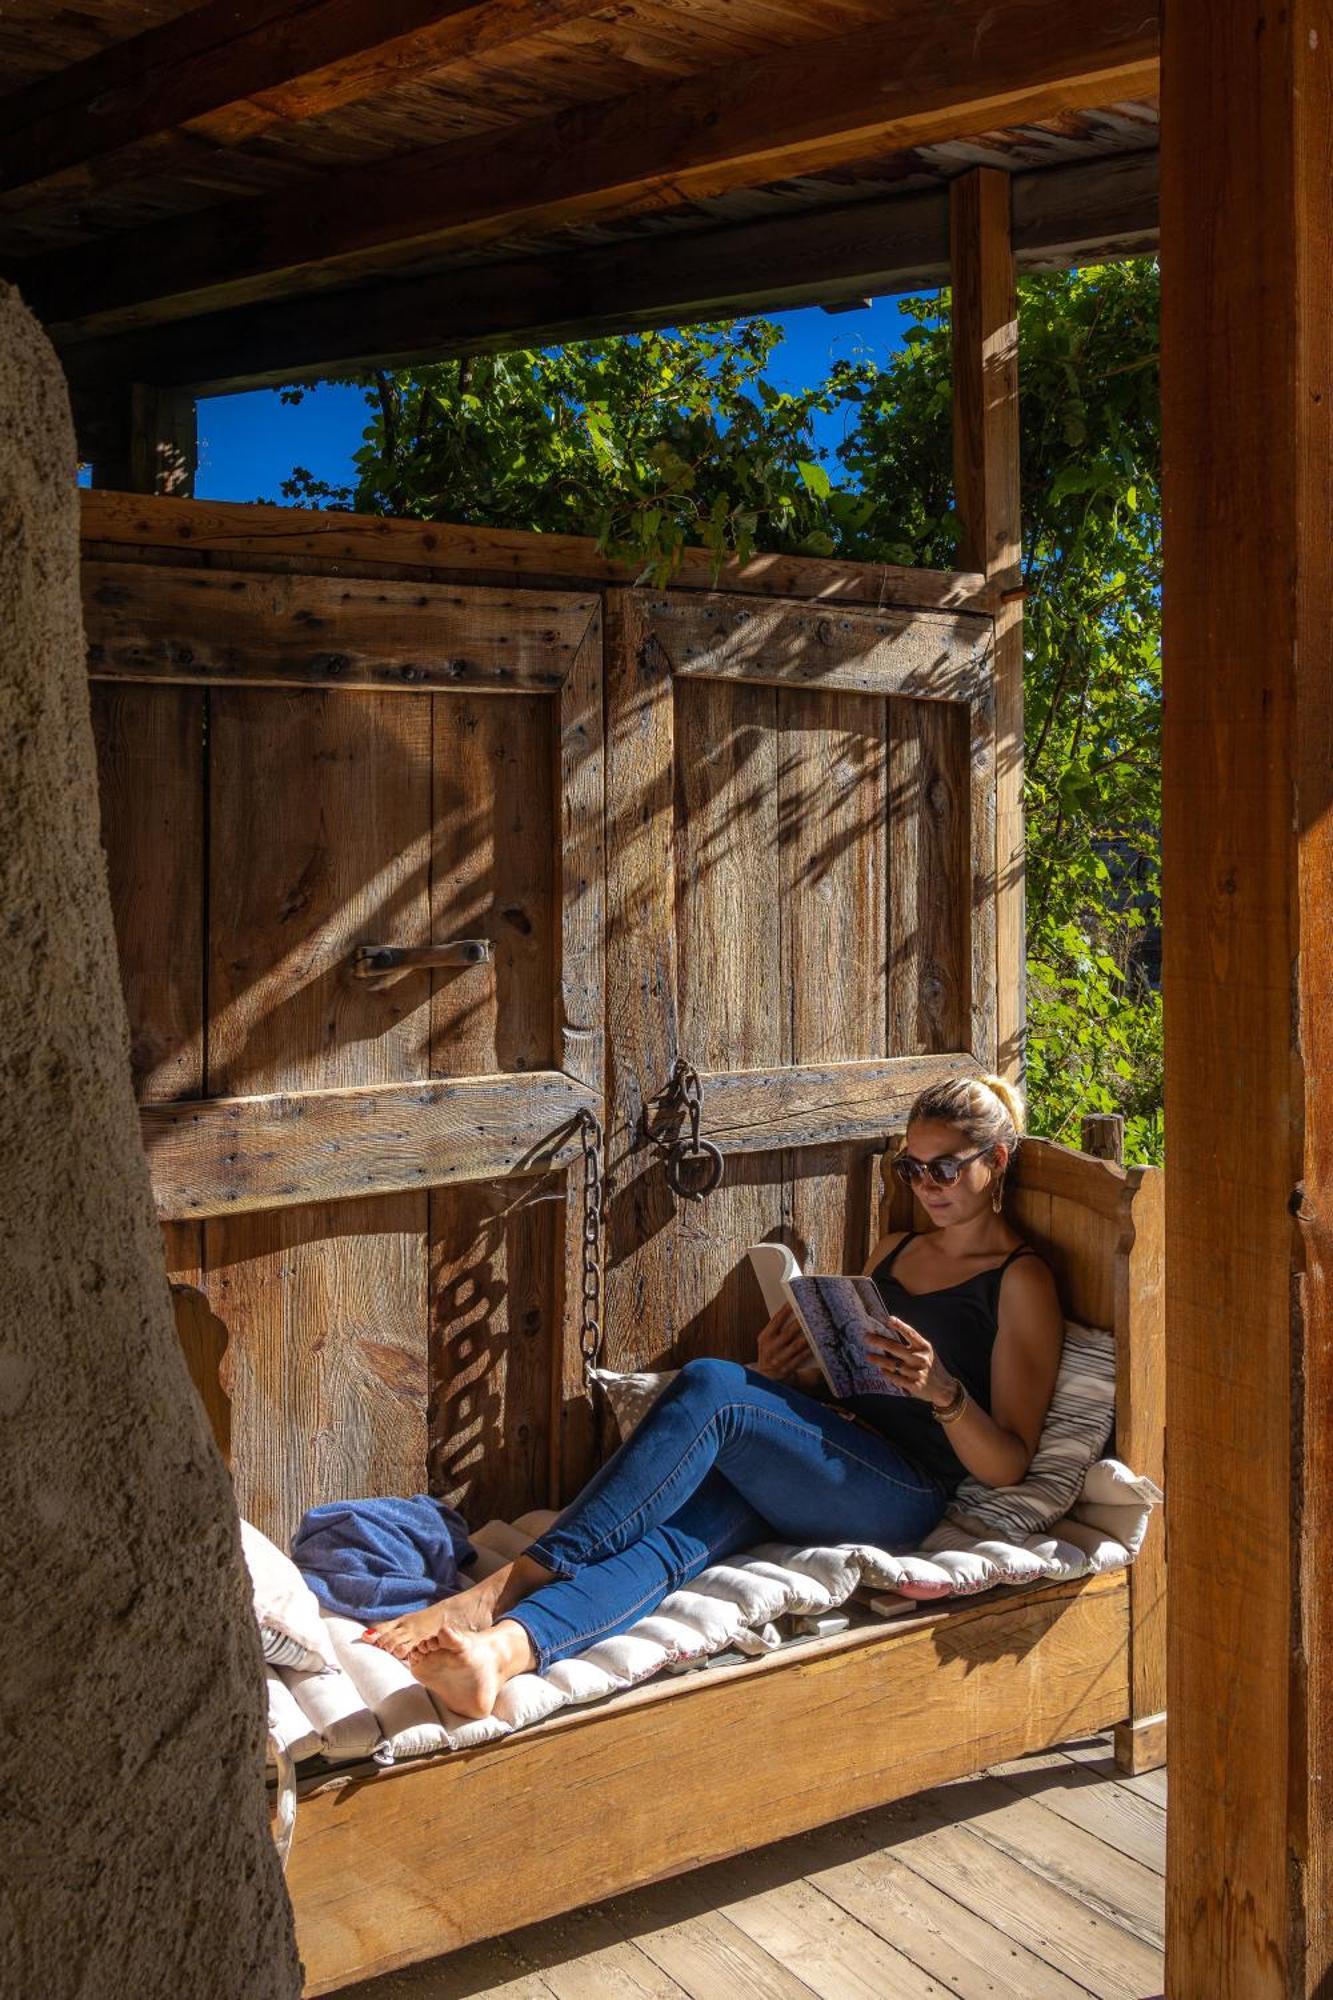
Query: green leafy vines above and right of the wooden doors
286,262,1163,1160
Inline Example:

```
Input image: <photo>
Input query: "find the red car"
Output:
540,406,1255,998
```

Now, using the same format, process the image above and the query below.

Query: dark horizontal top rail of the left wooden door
82,562,594,694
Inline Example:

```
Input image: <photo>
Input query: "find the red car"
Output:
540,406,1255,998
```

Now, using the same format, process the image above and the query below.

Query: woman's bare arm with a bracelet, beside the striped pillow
860,1256,1065,1486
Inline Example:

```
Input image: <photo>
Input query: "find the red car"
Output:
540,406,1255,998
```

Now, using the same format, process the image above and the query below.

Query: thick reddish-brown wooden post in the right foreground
1161,0,1333,2000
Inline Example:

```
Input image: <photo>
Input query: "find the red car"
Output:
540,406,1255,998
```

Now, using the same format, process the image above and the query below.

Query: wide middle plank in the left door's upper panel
208,688,430,1096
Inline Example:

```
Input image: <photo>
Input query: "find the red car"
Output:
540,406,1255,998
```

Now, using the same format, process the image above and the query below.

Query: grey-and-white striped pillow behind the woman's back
947,1320,1115,1542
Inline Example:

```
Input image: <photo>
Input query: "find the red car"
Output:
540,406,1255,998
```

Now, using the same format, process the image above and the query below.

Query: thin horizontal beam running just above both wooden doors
78,490,991,616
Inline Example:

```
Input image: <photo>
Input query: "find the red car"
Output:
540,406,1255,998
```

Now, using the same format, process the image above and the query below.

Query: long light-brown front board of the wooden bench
288,1578,1127,1994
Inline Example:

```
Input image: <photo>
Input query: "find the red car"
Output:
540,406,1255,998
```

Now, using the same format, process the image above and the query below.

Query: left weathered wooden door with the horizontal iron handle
84,556,604,1540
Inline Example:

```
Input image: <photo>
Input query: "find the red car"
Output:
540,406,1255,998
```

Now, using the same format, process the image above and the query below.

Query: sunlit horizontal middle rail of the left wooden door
140,1070,596,1218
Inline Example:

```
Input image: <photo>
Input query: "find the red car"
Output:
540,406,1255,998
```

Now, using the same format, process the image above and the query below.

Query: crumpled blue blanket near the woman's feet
292,1494,476,1624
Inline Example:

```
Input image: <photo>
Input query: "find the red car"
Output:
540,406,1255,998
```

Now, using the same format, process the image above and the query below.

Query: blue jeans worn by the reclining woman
504,1360,949,1672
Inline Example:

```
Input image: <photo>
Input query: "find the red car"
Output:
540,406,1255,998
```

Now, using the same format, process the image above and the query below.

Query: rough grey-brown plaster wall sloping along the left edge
0,284,300,2000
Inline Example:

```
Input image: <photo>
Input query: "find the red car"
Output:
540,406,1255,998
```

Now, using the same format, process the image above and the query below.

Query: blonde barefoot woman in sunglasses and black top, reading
366,1076,1063,1716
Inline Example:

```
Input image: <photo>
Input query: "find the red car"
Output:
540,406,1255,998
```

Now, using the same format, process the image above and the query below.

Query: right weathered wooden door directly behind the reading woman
606,592,997,1464
